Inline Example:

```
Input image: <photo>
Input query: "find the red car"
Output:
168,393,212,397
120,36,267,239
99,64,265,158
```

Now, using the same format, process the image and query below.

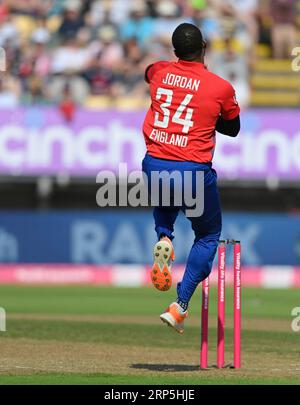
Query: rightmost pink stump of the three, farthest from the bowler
233,242,241,368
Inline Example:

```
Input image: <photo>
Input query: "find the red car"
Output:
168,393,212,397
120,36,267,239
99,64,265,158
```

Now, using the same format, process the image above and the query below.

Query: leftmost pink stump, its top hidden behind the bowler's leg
200,277,209,368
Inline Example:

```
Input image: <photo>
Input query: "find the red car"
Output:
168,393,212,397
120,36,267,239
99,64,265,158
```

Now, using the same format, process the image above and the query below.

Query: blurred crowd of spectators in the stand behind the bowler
0,0,297,110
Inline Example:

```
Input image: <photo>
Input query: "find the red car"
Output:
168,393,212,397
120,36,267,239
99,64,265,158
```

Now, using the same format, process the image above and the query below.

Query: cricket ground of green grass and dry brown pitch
0,286,300,385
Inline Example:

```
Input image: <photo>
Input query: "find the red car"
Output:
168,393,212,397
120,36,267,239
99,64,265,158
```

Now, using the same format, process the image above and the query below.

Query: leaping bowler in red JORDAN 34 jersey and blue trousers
143,23,240,333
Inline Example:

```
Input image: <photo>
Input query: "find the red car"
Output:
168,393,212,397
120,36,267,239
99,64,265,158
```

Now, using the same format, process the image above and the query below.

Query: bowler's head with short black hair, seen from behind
172,23,206,61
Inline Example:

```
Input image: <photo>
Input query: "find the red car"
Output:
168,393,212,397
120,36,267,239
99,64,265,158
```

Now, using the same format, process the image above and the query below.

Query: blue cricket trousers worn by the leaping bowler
142,154,222,303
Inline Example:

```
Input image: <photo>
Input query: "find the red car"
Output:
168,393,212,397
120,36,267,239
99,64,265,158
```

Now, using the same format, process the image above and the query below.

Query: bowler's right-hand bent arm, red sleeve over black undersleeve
216,82,241,137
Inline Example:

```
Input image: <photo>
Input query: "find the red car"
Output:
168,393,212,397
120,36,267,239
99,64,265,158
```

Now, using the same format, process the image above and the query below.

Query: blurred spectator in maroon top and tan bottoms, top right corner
269,0,297,59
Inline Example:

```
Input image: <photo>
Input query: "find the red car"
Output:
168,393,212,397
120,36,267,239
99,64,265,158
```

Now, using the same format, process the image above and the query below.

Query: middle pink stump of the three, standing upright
217,241,226,368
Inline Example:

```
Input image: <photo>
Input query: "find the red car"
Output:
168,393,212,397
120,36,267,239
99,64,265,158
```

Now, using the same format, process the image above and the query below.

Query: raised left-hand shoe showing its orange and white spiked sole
151,236,175,291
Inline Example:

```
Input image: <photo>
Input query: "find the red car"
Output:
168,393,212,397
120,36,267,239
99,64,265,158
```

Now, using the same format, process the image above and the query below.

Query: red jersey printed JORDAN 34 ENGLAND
143,60,240,163
